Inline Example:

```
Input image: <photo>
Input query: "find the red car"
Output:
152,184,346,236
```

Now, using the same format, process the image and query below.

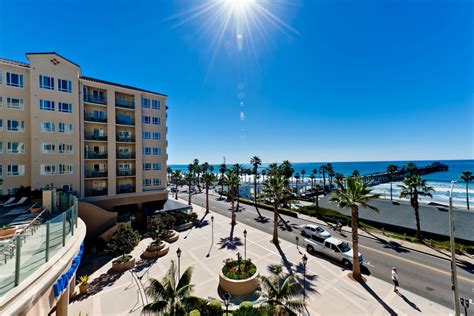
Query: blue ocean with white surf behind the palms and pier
170,159,474,210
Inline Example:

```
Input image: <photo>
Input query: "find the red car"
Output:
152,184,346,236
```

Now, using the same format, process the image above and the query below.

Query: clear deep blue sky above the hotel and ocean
0,0,474,163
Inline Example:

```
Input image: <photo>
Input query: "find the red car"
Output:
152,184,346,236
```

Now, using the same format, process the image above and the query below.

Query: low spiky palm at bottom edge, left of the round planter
142,260,200,316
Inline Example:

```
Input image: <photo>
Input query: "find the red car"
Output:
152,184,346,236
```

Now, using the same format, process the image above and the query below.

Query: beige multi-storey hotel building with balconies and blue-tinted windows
0,53,167,205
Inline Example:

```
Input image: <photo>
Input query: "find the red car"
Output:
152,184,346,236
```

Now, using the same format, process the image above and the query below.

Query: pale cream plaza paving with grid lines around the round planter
70,199,450,315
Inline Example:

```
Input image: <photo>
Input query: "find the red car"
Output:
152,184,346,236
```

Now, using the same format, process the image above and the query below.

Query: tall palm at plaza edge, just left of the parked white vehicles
262,174,291,245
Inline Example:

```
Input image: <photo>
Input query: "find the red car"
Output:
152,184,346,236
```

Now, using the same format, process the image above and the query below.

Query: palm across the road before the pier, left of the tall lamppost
400,174,434,240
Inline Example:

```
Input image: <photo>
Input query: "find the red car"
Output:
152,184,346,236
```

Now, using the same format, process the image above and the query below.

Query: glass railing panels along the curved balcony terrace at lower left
0,193,78,297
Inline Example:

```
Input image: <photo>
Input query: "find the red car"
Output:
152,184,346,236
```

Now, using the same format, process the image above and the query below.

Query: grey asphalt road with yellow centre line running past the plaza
180,194,474,307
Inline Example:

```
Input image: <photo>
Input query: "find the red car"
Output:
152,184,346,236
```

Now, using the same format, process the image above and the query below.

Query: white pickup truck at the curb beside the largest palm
305,234,364,266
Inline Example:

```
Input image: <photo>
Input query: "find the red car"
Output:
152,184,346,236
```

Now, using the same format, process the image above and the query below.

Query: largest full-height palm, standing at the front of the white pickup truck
329,177,380,281
